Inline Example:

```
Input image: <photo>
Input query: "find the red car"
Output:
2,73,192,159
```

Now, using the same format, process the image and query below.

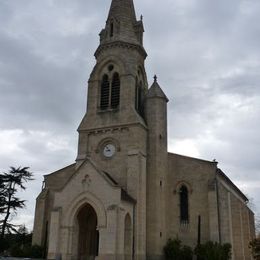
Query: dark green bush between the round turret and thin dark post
164,239,193,260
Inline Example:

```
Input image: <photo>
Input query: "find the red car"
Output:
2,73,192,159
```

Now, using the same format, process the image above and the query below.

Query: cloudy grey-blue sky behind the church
0,0,260,232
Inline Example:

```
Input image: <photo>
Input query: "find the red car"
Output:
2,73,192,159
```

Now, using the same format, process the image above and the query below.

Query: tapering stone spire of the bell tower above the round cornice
96,0,144,51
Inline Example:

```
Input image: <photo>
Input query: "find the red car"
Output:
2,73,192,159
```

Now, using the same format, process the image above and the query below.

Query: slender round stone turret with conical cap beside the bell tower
145,76,168,256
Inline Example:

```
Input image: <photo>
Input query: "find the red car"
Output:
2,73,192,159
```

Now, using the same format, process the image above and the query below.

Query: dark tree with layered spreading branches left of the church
0,167,33,239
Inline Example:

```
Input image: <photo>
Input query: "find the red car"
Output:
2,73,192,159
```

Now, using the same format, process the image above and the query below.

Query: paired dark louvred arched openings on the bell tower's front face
100,72,120,110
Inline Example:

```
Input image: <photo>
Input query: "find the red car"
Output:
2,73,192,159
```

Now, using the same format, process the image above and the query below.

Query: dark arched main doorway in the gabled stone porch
77,204,99,260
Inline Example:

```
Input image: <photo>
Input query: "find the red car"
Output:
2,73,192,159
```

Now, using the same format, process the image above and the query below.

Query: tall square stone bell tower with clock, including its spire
76,0,148,259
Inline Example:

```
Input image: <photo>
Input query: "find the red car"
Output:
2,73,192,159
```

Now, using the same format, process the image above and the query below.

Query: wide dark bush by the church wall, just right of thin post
195,241,231,260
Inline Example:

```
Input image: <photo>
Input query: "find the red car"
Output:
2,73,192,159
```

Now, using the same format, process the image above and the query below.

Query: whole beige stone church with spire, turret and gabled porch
33,0,255,260
